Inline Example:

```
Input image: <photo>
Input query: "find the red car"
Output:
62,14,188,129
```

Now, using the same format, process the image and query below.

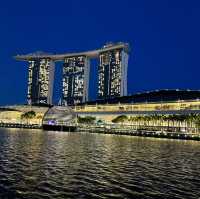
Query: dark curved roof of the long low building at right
76,89,200,105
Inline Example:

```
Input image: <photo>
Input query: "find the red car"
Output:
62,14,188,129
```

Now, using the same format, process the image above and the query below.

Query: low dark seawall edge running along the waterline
0,123,200,141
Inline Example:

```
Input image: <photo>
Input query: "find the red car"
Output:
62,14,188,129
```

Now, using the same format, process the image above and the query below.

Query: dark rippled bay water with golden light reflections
0,129,200,199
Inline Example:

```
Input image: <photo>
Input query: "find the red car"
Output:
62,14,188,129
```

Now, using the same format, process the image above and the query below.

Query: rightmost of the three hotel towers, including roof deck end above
98,44,128,99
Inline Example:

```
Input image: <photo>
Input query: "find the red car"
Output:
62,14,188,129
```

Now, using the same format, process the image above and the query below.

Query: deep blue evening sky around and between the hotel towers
0,0,200,105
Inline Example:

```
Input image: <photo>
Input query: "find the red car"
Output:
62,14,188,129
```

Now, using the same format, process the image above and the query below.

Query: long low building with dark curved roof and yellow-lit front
71,89,200,121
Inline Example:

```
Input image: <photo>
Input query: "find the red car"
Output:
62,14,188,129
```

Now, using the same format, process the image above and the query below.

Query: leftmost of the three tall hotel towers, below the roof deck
27,58,54,104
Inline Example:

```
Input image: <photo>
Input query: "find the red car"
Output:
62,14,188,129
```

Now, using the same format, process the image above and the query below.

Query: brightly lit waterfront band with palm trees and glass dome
0,106,200,140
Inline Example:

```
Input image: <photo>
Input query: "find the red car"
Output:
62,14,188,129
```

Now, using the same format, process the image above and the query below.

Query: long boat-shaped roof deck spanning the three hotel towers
15,42,129,61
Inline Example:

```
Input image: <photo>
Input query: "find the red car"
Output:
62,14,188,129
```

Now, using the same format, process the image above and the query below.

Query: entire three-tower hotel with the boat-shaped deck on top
15,42,129,106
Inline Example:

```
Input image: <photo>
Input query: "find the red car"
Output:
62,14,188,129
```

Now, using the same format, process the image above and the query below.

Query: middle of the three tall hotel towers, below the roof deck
62,55,90,105
